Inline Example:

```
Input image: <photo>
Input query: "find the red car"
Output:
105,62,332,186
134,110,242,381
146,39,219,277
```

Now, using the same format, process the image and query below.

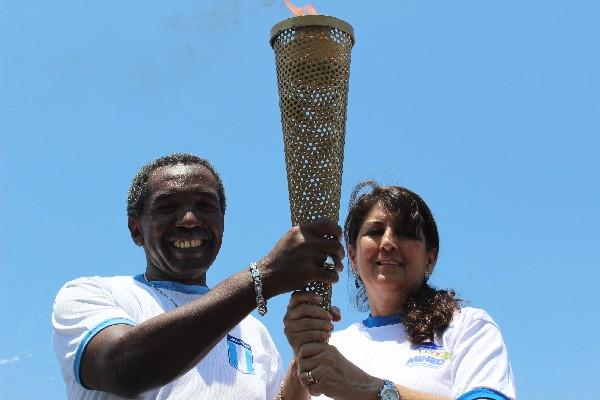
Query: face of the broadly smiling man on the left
129,164,223,284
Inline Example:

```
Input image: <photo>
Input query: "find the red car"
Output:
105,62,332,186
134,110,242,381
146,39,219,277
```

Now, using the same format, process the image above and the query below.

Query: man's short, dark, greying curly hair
127,153,227,218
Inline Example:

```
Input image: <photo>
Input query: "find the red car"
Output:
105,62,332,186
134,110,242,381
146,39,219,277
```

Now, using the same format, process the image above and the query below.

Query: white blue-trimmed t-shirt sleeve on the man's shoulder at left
52,278,135,385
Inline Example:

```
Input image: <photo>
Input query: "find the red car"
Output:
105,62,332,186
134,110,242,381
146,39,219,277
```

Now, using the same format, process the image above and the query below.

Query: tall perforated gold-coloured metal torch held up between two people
270,0,354,310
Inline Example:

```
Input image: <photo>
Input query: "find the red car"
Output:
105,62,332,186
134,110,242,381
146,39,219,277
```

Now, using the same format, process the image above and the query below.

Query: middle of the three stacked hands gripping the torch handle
283,292,340,357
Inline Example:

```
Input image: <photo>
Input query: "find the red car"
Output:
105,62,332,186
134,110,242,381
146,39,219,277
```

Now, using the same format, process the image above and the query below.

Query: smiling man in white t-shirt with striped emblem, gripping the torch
52,154,343,400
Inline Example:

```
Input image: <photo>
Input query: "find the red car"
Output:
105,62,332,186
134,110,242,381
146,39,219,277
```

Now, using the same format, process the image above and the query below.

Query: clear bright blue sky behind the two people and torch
0,0,600,399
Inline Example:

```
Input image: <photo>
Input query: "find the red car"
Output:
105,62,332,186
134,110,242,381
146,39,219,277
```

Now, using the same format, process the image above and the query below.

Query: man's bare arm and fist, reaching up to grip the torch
80,220,343,397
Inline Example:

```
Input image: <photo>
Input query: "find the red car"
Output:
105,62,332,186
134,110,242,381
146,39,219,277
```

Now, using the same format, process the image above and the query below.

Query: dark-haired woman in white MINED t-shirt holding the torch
280,181,515,400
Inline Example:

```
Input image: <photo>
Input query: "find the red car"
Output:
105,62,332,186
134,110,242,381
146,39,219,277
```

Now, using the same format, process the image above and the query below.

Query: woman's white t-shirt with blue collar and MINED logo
317,307,516,400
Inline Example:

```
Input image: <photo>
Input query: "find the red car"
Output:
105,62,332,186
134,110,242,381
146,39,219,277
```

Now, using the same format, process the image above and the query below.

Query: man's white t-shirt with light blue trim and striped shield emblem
52,275,285,400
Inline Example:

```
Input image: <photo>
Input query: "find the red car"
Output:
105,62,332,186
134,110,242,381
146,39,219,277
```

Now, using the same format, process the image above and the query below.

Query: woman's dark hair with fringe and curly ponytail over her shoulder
344,181,462,344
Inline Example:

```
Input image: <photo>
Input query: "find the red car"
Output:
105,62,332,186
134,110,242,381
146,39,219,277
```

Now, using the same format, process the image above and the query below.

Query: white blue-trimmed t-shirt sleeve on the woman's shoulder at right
452,309,516,399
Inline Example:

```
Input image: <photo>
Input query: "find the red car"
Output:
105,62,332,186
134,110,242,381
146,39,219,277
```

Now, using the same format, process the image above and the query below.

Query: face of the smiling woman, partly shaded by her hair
348,203,437,315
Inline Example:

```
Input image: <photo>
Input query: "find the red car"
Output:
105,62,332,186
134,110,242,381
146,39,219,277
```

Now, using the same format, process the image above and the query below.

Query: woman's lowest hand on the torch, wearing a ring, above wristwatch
297,342,383,400
